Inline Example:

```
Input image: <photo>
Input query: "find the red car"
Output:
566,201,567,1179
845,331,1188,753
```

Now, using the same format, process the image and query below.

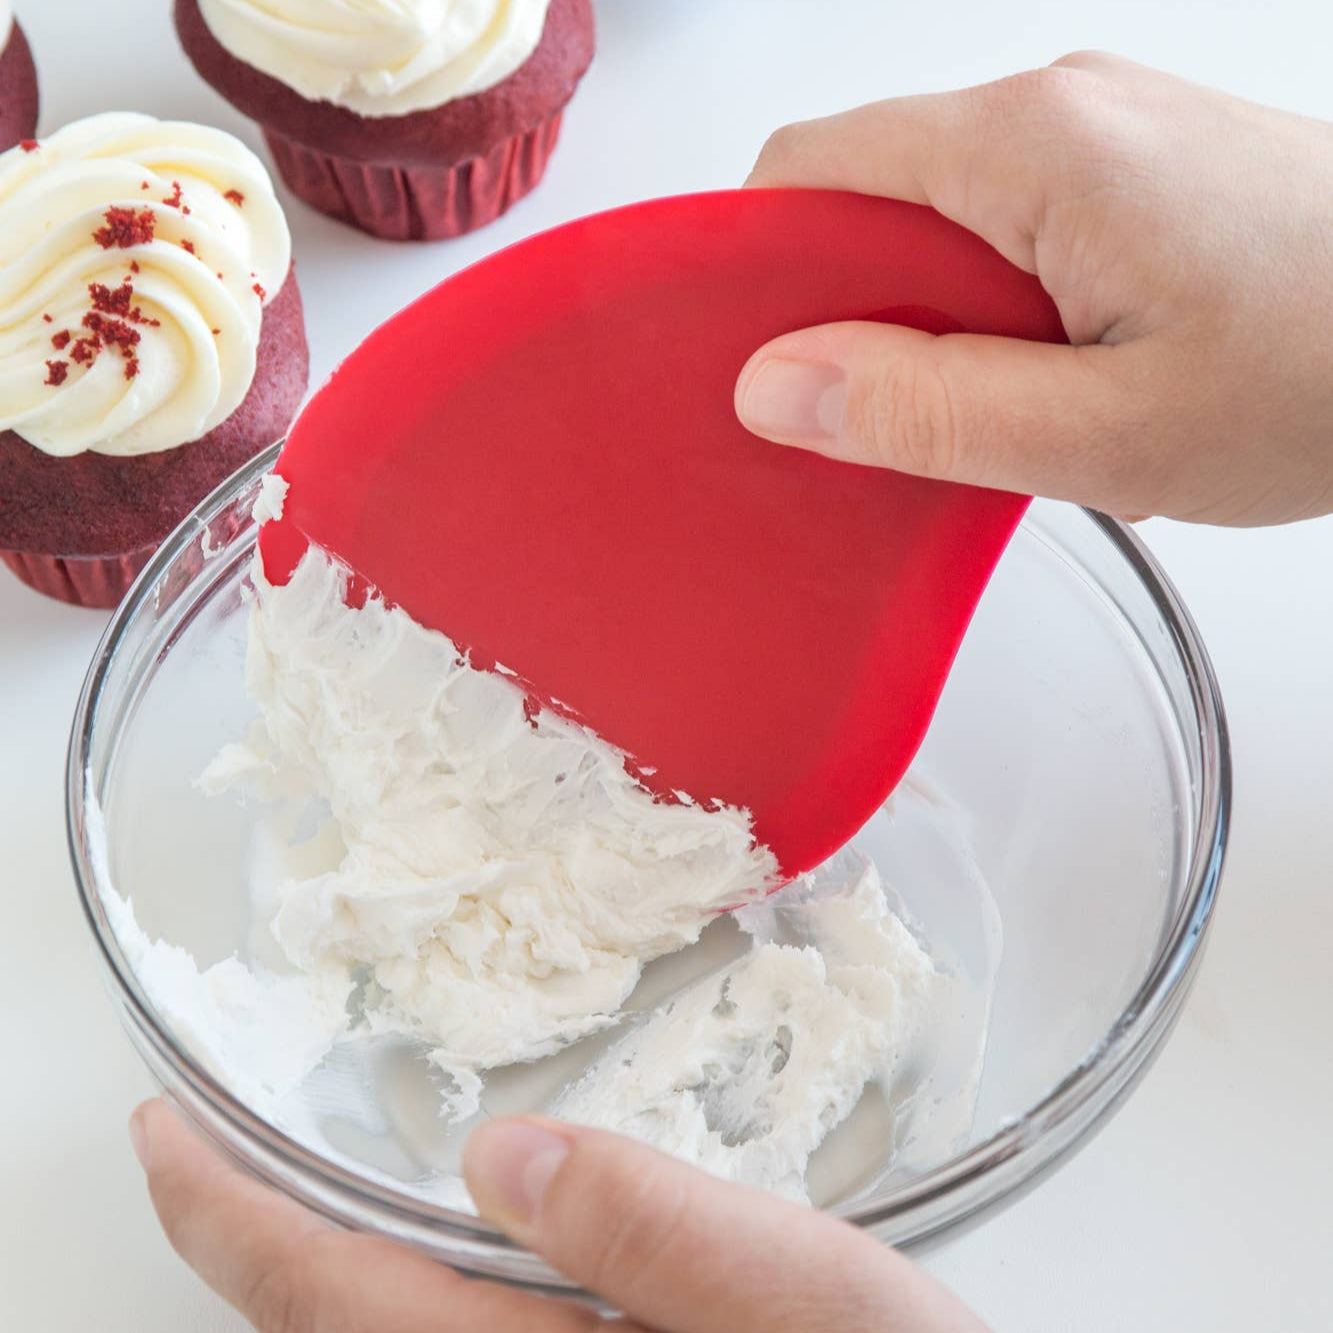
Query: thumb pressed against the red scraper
736,323,1170,513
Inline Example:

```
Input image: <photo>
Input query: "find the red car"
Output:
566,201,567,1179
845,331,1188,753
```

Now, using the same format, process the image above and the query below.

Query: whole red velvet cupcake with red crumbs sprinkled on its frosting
0,113,309,607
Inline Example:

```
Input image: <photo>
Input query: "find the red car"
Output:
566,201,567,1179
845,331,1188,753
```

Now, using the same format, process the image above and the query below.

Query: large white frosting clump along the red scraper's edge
208,548,777,1072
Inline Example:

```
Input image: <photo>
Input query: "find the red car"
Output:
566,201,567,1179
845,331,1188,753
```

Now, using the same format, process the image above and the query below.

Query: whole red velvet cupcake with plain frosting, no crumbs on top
176,0,593,240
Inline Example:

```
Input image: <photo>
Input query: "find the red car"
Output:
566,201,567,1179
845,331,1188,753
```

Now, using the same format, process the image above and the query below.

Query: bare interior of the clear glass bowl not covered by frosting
76,469,1209,1238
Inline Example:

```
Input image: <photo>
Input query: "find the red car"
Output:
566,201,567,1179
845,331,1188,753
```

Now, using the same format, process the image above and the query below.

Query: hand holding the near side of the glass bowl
131,1101,985,1333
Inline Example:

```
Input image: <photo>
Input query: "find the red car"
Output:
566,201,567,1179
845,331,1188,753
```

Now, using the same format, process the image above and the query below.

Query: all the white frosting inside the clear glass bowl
104,527,990,1206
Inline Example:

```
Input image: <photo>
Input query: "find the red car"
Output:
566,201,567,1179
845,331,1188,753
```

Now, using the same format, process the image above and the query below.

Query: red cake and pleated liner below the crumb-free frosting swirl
175,0,595,240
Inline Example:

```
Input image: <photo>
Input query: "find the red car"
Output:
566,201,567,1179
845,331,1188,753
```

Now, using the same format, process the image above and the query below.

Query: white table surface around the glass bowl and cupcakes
0,0,1333,1333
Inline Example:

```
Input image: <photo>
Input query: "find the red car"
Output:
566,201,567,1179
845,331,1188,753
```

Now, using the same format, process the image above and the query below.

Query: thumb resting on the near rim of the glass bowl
464,1117,985,1333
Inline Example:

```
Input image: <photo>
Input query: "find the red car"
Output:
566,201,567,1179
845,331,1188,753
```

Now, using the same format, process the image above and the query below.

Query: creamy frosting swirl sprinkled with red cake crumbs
0,114,292,456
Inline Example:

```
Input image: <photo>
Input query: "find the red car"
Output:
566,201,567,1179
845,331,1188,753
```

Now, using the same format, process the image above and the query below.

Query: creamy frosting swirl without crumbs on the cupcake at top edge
199,0,549,116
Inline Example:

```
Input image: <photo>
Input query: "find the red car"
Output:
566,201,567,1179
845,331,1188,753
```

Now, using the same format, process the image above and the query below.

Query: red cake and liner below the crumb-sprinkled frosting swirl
0,272,309,607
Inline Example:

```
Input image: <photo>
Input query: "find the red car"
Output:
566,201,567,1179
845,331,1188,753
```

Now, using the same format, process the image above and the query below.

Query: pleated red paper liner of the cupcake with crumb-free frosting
264,112,560,241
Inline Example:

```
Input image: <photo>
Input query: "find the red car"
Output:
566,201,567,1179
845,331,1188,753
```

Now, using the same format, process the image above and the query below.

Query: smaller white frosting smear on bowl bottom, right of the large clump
551,862,944,1201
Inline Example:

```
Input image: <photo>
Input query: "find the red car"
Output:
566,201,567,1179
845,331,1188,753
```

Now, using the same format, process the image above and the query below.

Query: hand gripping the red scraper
736,53,1333,524
